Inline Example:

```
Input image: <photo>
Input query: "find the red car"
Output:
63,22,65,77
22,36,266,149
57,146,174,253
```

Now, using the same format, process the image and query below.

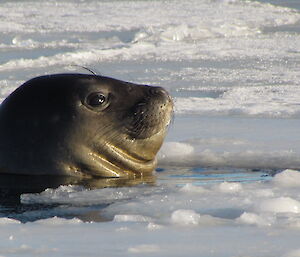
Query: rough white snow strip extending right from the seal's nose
175,86,300,118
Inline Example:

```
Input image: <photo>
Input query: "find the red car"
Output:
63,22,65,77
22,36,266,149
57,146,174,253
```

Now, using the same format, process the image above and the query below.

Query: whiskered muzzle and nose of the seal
124,87,173,139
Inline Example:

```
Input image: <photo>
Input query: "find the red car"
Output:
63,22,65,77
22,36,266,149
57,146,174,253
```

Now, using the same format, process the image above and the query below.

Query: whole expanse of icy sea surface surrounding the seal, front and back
0,0,300,254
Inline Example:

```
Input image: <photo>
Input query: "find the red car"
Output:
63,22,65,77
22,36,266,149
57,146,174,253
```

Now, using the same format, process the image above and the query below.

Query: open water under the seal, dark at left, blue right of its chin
0,167,274,222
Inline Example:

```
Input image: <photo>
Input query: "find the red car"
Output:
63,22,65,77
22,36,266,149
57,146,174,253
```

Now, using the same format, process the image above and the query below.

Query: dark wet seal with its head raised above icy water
0,74,173,178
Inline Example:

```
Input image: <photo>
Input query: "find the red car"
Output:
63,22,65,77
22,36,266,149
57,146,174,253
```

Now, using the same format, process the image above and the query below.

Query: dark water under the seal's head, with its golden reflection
0,174,155,222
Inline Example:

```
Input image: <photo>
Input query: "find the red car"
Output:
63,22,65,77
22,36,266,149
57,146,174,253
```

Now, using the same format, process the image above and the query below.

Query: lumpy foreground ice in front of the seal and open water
0,170,300,256
